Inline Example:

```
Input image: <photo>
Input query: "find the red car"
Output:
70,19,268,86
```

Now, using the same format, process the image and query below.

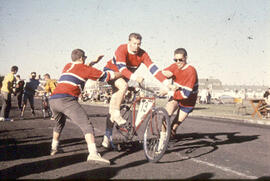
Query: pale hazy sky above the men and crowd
0,0,270,86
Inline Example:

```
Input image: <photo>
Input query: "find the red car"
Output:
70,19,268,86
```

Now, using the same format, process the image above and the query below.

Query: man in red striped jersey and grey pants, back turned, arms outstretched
50,49,120,164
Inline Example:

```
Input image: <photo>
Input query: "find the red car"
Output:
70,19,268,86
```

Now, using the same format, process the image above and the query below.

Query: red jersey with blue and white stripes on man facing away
51,62,111,99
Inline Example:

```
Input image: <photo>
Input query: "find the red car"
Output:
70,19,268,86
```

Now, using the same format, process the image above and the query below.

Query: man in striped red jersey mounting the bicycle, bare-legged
102,33,166,147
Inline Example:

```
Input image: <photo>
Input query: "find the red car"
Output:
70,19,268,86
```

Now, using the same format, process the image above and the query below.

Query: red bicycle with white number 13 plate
116,84,170,162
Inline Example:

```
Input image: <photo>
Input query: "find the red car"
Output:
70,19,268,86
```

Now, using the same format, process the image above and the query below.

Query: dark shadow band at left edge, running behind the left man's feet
0,136,86,161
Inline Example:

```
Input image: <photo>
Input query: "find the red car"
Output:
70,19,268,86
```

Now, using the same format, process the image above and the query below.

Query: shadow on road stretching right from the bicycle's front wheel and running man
160,132,260,163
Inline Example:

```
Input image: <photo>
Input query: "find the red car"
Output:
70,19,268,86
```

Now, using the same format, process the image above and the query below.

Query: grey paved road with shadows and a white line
0,102,270,179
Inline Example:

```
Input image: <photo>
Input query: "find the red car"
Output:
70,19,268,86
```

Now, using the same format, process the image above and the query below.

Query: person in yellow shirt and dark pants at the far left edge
0,66,18,121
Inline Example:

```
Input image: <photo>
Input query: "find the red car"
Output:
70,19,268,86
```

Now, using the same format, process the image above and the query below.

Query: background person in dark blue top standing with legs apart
21,72,39,119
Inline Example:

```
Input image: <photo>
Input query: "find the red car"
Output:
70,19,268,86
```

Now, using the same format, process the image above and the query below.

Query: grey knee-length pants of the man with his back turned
49,97,94,135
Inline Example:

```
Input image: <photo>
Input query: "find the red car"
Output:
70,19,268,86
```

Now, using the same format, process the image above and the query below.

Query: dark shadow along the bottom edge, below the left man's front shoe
59,160,148,180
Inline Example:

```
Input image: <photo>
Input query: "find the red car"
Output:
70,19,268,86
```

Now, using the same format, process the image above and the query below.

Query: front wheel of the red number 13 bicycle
143,107,171,162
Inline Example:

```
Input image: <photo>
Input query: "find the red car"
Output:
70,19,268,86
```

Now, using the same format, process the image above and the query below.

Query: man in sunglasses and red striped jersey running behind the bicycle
160,48,199,143
